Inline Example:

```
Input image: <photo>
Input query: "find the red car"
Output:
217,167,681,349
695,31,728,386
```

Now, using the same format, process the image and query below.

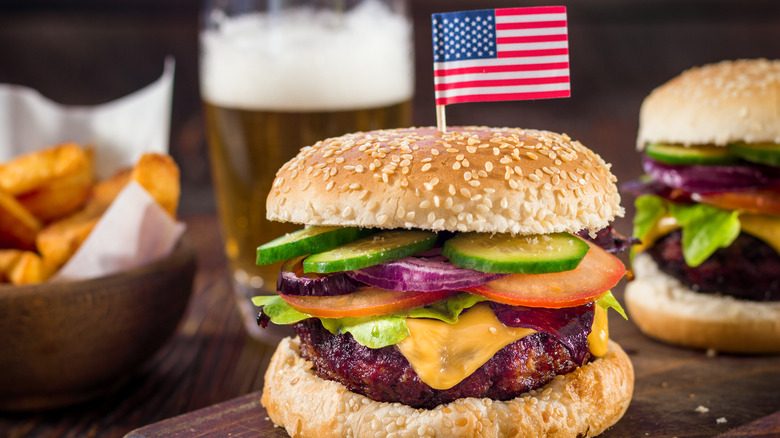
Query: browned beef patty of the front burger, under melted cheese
295,318,590,409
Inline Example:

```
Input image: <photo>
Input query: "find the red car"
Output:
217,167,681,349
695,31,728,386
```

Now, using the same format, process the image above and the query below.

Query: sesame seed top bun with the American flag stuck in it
267,127,623,234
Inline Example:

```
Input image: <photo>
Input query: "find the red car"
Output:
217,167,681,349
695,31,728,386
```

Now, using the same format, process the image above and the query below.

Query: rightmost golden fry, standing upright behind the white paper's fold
132,153,181,217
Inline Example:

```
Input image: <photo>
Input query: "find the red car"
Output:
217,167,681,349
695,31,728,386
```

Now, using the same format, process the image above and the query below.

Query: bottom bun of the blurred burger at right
625,253,780,353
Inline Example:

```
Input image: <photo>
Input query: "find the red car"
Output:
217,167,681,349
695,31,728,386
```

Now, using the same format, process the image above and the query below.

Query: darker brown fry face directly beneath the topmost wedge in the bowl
16,157,93,223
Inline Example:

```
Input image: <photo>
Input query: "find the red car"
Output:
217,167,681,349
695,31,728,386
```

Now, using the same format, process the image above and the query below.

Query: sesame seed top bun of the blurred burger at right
637,59,780,149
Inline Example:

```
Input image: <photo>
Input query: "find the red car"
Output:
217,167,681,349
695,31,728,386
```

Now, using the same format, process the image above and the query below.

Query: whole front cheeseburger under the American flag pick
255,127,634,437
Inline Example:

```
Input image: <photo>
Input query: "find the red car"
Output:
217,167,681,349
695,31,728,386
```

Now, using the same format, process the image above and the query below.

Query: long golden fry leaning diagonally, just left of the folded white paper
35,170,130,269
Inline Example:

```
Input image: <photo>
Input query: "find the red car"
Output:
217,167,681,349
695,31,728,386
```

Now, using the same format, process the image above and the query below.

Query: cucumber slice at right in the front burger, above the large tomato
441,233,589,274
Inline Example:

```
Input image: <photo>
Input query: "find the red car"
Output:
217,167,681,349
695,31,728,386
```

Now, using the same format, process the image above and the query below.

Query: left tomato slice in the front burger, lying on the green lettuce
279,286,458,318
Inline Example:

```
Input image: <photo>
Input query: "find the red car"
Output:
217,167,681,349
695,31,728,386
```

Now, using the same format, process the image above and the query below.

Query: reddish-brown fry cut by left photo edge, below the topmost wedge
0,190,41,250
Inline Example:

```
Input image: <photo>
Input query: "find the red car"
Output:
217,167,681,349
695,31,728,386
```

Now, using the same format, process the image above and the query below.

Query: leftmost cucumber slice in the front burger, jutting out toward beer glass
257,226,377,265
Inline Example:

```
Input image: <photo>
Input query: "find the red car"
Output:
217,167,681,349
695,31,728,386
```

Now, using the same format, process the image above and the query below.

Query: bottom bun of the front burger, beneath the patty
261,338,634,438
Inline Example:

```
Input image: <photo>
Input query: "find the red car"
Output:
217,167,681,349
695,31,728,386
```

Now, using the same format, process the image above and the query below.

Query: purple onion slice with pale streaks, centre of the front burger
346,256,507,292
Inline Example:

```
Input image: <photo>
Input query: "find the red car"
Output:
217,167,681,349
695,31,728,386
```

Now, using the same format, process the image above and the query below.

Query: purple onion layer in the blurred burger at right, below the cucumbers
642,157,780,193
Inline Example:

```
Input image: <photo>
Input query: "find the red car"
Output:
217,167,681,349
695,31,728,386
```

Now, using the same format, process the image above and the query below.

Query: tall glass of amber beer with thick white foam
200,0,414,338
